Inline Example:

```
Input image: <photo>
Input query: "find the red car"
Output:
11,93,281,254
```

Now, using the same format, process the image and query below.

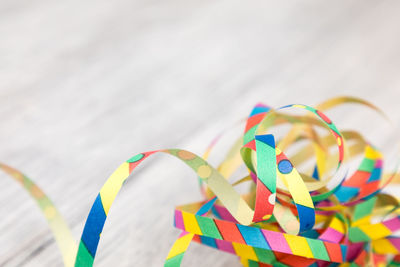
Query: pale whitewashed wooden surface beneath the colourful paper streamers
0,0,400,267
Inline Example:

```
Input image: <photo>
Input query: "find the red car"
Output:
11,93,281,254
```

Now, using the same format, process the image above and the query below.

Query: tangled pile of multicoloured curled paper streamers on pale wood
0,97,400,267
